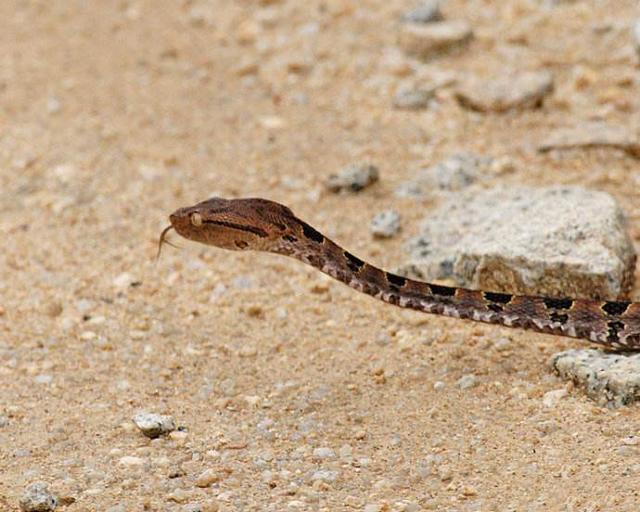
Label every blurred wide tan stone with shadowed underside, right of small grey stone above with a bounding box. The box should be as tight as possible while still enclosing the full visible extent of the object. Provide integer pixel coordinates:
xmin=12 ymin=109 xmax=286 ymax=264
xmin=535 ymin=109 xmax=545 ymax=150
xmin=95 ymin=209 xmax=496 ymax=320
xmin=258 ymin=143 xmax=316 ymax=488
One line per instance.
xmin=456 ymin=71 xmax=553 ymax=112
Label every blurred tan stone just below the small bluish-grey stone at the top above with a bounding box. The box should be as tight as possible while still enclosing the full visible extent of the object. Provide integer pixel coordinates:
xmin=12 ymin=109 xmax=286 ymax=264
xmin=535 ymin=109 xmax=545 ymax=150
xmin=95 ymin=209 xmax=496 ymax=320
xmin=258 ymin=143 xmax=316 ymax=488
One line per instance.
xmin=398 ymin=20 xmax=473 ymax=60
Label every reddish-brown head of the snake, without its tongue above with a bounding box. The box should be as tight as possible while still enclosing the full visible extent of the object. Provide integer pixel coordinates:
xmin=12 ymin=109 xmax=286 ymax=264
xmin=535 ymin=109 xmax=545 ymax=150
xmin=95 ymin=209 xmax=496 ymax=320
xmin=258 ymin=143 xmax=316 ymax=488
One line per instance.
xmin=169 ymin=197 xmax=296 ymax=250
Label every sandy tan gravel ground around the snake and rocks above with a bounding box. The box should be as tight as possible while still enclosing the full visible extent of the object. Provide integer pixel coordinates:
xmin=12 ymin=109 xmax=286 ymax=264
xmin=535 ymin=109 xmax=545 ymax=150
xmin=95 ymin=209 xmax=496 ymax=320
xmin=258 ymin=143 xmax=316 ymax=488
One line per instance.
xmin=0 ymin=0 xmax=640 ymax=512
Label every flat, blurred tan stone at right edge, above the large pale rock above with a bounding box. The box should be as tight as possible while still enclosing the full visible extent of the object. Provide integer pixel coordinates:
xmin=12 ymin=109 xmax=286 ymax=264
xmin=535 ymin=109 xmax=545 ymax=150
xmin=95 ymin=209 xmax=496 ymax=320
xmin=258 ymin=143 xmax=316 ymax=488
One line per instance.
xmin=538 ymin=121 xmax=640 ymax=158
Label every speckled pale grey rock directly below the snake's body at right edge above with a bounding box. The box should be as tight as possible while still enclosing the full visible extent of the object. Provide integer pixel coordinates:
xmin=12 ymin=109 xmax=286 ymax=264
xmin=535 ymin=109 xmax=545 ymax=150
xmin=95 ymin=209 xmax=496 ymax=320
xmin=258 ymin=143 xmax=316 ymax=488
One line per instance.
xmin=550 ymin=349 xmax=640 ymax=408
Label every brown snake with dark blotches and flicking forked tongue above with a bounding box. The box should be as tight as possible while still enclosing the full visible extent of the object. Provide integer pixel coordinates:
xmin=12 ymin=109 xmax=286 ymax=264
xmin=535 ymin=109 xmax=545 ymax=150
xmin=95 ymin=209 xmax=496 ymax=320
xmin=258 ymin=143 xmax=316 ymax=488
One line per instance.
xmin=158 ymin=197 xmax=640 ymax=350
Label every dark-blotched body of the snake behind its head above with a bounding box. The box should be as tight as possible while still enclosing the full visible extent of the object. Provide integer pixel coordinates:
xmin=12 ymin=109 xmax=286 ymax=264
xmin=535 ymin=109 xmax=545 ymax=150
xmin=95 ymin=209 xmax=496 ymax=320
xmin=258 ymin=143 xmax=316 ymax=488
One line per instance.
xmin=274 ymin=230 xmax=640 ymax=350
